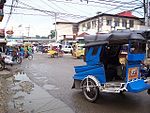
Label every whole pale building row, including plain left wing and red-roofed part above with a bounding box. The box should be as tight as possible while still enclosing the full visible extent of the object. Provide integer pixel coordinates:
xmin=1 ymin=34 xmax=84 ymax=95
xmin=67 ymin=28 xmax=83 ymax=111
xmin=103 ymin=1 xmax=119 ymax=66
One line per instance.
xmin=56 ymin=11 xmax=144 ymax=40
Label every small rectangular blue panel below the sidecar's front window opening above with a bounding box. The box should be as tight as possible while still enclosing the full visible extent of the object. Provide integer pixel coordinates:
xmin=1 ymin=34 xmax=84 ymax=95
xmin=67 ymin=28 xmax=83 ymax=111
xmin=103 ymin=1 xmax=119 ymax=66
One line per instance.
xmin=128 ymin=53 xmax=145 ymax=61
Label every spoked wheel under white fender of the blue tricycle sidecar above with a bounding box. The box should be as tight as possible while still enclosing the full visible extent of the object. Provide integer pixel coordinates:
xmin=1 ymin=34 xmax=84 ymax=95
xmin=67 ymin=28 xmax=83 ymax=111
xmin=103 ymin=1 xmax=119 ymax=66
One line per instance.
xmin=82 ymin=78 xmax=99 ymax=102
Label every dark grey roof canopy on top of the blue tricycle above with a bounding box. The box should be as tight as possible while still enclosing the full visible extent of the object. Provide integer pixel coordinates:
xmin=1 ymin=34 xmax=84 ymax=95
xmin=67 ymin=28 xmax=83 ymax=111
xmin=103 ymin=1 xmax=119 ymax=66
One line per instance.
xmin=84 ymin=32 xmax=145 ymax=47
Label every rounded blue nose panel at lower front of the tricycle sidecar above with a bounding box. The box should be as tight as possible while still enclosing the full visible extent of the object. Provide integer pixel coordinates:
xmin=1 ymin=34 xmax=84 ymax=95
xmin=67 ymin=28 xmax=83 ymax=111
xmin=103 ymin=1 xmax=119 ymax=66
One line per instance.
xmin=127 ymin=80 xmax=150 ymax=93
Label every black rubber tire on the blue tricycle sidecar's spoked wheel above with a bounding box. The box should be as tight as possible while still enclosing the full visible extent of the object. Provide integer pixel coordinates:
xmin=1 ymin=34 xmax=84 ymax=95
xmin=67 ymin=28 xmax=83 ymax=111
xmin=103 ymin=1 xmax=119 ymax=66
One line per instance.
xmin=82 ymin=78 xmax=99 ymax=102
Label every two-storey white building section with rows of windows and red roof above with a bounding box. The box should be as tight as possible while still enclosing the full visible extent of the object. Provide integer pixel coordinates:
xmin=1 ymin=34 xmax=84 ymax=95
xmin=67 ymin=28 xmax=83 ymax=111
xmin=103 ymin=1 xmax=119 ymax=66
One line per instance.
xmin=78 ymin=12 xmax=143 ymax=34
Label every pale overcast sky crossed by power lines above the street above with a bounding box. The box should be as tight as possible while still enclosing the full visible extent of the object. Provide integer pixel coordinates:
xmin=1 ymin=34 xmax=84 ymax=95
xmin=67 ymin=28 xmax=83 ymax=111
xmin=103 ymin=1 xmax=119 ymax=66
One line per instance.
xmin=0 ymin=0 xmax=143 ymax=36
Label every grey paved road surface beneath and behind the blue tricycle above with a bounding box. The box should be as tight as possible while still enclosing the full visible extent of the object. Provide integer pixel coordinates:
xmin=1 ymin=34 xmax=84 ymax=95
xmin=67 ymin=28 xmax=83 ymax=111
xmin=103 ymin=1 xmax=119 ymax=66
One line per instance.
xmin=22 ymin=54 xmax=150 ymax=113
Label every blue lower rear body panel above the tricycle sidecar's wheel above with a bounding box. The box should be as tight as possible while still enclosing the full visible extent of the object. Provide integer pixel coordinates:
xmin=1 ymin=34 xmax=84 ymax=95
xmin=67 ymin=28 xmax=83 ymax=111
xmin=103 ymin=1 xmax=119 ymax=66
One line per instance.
xmin=73 ymin=66 xmax=106 ymax=83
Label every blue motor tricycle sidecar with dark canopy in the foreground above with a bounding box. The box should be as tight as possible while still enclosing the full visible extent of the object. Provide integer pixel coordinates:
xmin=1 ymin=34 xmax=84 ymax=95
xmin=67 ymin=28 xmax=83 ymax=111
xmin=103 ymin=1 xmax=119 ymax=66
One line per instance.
xmin=72 ymin=32 xmax=150 ymax=102
